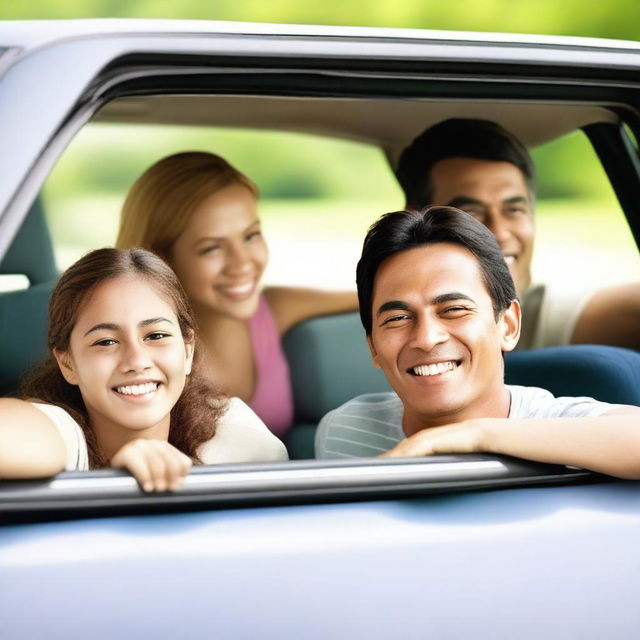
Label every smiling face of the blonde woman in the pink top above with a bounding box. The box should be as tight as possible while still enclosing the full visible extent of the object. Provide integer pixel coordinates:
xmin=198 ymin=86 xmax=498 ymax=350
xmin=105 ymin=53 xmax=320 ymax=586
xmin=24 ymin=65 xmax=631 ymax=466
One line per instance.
xmin=169 ymin=184 xmax=268 ymax=320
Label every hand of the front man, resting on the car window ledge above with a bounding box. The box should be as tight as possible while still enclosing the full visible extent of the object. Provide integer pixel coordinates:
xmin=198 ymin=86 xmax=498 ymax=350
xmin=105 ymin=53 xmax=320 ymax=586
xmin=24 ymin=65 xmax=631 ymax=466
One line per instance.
xmin=381 ymin=420 xmax=487 ymax=458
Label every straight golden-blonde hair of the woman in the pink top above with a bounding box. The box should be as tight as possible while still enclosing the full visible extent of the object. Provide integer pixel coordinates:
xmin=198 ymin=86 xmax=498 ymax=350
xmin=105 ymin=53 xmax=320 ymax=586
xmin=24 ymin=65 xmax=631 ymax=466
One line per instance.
xmin=116 ymin=151 xmax=258 ymax=259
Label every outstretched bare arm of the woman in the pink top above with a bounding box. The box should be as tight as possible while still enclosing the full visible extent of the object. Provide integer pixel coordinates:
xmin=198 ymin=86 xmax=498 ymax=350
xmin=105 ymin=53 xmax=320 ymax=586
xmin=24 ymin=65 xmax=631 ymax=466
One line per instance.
xmin=265 ymin=287 xmax=358 ymax=335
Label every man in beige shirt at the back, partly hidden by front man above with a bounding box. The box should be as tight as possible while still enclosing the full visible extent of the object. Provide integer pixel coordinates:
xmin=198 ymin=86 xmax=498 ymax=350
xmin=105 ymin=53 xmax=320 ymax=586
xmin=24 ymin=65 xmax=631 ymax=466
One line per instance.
xmin=396 ymin=119 xmax=640 ymax=349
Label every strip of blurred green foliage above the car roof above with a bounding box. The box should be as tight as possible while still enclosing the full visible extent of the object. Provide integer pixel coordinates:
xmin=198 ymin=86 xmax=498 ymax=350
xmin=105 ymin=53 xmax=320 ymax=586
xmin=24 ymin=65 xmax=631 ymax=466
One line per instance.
xmin=0 ymin=0 xmax=640 ymax=40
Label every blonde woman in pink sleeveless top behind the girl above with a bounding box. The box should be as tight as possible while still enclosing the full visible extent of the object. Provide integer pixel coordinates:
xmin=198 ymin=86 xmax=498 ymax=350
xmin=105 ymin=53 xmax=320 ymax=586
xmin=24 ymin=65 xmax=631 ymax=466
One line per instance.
xmin=116 ymin=152 xmax=358 ymax=436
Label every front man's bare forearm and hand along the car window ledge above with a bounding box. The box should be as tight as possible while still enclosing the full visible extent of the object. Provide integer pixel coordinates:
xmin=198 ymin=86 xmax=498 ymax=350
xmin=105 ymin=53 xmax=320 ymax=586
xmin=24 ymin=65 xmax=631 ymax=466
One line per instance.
xmin=384 ymin=406 xmax=640 ymax=480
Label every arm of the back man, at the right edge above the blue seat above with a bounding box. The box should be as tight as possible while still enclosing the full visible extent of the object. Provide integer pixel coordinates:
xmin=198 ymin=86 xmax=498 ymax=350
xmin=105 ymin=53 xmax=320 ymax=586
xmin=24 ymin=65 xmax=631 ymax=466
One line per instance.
xmin=571 ymin=283 xmax=640 ymax=350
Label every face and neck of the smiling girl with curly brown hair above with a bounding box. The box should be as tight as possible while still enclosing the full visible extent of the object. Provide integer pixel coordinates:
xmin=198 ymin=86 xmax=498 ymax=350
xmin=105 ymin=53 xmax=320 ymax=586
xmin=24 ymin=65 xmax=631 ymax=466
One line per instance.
xmin=55 ymin=276 xmax=193 ymax=439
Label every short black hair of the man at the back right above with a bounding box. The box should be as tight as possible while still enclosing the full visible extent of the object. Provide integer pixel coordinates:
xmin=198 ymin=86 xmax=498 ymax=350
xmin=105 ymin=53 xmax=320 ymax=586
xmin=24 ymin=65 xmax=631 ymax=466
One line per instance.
xmin=396 ymin=118 xmax=535 ymax=209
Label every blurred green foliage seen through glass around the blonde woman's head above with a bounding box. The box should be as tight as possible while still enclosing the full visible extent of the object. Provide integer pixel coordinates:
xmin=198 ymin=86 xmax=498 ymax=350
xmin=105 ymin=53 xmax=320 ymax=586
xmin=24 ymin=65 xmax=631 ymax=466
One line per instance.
xmin=46 ymin=124 xmax=402 ymax=206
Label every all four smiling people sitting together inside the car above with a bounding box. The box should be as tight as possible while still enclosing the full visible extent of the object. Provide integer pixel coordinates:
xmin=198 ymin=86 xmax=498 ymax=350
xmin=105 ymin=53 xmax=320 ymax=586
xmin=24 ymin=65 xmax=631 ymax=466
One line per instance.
xmin=0 ymin=120 xmax=640 ymax=484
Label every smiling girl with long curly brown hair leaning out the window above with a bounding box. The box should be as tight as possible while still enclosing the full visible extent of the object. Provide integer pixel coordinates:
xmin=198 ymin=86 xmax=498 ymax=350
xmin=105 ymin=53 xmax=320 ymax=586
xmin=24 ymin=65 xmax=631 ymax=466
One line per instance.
xmin=0 ymin=249 xmax=286 ymax=491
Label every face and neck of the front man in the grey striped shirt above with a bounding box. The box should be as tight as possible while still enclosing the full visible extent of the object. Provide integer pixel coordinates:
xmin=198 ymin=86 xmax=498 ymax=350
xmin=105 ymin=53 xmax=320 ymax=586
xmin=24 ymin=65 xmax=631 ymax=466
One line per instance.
xmin=368 ymin=243 xmax=520 ymax=435
